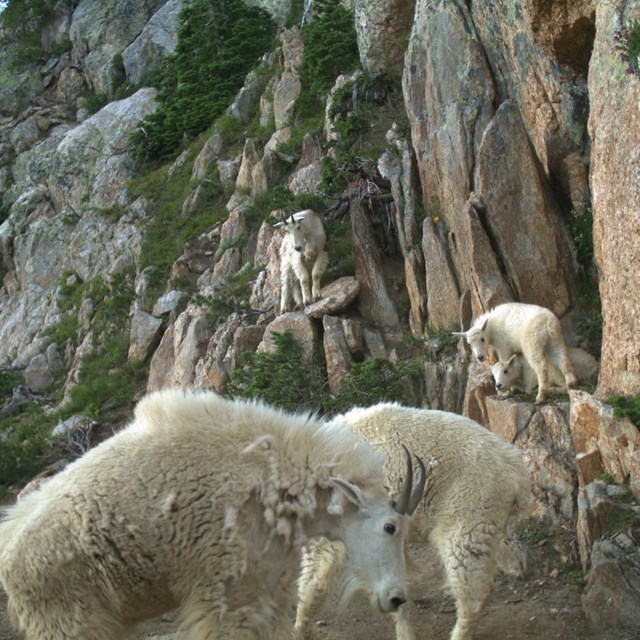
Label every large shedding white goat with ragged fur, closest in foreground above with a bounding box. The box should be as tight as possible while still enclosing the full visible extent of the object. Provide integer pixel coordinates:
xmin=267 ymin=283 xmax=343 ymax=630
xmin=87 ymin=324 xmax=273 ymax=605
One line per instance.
xmin=0 ymin=390 xmax=424 ymax=640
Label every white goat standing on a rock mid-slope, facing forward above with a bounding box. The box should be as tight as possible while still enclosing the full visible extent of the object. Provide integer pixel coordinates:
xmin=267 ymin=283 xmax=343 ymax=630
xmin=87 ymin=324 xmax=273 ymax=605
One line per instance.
xmin=279 ymin=209 xmax=329 ymax=313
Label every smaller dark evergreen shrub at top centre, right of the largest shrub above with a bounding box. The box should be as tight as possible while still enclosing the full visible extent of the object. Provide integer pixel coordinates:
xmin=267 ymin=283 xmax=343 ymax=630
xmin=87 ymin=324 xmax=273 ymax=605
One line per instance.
xmin=301 ymin=0 xmax=360 ymax=93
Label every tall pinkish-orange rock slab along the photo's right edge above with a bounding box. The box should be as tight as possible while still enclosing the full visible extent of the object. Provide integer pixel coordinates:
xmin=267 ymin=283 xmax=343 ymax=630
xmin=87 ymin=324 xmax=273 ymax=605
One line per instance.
xmin=589 ymin=2 xmax=640 ymax=398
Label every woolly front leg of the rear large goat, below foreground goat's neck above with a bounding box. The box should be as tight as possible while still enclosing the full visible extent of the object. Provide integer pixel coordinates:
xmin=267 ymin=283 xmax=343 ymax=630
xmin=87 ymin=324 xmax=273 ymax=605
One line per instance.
xmin=295 ymin=539 xmax=346 ymax=640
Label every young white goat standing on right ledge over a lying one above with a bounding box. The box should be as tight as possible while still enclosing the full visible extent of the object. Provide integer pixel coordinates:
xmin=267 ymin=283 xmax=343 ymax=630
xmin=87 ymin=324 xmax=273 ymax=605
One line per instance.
xmin=453 ymin=302 xmax=577 ymax=403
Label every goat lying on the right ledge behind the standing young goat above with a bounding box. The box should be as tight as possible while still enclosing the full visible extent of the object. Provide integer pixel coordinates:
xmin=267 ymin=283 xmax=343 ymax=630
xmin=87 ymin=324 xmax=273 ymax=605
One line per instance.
xmin=491 ymin=347 xmax=598 ymax=396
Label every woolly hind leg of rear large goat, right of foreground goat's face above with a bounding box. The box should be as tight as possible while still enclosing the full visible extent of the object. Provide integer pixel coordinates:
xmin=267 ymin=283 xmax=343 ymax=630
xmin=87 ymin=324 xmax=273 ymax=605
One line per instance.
xmin=441 ymin=524 xmax=499 ymax=640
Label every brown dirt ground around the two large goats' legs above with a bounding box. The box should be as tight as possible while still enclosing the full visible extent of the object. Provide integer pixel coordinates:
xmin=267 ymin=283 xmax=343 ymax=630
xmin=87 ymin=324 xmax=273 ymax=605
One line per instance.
xmin=0 ymin=540 xmax=640 ymax=640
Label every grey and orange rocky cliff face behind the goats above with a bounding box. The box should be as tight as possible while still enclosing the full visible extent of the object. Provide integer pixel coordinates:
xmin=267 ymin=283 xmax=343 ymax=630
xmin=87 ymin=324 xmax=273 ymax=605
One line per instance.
xmin=0 ymin=0 xmax=640 ymax=628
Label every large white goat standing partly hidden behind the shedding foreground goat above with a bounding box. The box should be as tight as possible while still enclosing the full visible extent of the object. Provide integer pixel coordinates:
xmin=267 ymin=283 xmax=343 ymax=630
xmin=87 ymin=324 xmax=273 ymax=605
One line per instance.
xmin=295 ymin=404 xmax=532 ymax=640
